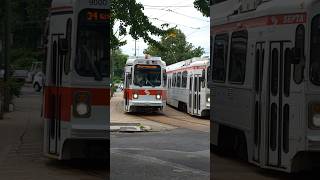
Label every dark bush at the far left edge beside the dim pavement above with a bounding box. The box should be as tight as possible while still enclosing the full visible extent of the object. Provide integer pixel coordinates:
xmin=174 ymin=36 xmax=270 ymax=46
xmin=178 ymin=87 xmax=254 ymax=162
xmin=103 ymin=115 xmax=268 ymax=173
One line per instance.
xmin=0 ymin=78 xmax=23 ymax=112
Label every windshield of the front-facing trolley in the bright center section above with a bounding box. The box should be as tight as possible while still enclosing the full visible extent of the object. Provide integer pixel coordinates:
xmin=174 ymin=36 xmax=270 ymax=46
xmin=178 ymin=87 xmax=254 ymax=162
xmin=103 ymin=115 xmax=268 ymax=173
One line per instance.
xmin=133 ymin=65 xmax=161 ymax=87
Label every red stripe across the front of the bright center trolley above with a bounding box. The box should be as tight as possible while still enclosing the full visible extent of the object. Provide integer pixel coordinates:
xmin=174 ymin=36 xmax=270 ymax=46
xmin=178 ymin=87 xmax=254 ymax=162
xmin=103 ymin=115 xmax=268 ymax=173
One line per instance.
xmin=123 ymin=89 xmax=167 ymax=100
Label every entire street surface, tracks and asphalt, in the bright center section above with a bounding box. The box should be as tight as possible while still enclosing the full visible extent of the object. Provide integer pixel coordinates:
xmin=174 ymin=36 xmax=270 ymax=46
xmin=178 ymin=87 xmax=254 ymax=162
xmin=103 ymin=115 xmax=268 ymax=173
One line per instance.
xmin=110 ymin=93 xmax=210 ymax=180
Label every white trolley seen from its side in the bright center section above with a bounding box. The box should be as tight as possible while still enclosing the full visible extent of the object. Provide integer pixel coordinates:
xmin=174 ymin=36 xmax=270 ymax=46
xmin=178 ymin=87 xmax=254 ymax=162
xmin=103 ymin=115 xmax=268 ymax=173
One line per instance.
xmin=167 ymin=58 xmax=210 ymax=116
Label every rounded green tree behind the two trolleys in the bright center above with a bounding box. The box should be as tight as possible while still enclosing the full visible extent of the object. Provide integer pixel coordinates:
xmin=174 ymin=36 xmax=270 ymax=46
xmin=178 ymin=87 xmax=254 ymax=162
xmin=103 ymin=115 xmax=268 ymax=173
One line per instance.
xmin=145 ymin=28 xmax=205 ymax=65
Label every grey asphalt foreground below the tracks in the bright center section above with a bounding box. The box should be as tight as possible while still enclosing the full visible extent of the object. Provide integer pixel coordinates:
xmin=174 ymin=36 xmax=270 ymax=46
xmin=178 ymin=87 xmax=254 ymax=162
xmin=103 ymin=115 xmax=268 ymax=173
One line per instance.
xmin=110 ymin=129 xmax=210 ymax=180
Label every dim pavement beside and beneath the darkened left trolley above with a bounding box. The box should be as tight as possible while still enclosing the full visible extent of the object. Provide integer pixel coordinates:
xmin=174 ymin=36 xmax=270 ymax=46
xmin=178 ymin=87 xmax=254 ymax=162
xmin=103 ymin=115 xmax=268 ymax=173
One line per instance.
xmin=0 ymin=85 xmax=106 ymax=180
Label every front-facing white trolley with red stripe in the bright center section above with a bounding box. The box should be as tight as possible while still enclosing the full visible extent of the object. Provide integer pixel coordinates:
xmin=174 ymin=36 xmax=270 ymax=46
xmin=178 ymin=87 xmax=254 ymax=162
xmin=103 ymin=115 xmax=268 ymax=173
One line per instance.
xmin=124 ymin=56 xmax=167 ymax=112
